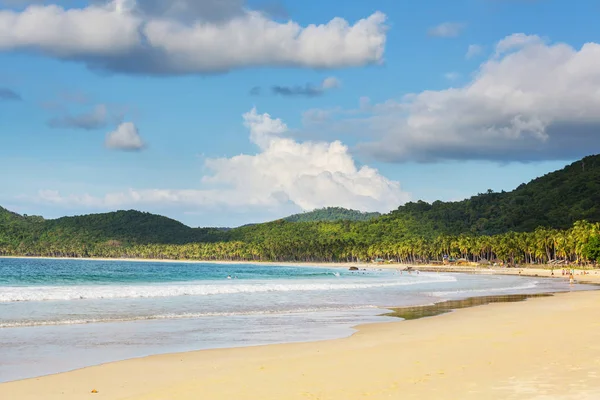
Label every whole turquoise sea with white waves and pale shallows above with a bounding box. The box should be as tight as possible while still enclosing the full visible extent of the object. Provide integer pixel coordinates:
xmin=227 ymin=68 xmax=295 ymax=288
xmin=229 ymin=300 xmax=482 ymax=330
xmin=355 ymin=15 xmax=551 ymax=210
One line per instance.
xmin=0 ymin=258 xmax=589 ymax=382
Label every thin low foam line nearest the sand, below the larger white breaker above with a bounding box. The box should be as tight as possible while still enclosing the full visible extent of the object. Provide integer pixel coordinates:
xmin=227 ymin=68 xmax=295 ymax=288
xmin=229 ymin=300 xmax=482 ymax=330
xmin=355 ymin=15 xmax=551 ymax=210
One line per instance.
xmin=0 ymin=305 xmax=379 ymax=329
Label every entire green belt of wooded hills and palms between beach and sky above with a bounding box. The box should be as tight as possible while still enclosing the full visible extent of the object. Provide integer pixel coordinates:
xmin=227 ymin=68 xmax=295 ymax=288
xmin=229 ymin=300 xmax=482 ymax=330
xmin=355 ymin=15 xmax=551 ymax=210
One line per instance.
xmin=0 ymin=156 xmax=600 ymax=262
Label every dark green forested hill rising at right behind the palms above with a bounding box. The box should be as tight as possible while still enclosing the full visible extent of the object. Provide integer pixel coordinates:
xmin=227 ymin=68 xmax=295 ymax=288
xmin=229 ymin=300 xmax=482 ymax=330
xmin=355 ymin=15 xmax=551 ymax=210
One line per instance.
xmin=384 ymin=155 xmax=600 ymax=234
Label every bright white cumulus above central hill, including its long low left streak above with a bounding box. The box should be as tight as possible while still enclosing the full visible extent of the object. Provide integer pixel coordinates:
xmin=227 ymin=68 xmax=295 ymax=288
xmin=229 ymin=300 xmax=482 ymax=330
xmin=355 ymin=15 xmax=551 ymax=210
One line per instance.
xmin=39 ymin=109 xmax=409 ymax=211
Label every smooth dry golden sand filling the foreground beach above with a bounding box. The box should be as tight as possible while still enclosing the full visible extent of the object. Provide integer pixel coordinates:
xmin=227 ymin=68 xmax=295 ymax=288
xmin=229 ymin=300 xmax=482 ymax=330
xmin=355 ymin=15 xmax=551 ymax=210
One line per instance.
xmin=0 ymin=291 xmax=600 ymax=400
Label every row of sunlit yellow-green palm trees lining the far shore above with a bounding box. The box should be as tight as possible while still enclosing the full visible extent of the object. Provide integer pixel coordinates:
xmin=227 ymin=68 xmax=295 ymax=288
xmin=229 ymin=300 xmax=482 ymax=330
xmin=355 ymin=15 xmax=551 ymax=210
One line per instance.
xmin=0 ymin=221 xmax=600 ymax=264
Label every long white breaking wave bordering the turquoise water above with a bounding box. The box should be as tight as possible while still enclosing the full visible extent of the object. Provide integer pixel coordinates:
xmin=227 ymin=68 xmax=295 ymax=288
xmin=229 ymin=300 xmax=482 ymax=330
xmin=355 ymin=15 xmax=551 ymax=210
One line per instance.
xmin=0 ymin=275 xmax=456 ymax=303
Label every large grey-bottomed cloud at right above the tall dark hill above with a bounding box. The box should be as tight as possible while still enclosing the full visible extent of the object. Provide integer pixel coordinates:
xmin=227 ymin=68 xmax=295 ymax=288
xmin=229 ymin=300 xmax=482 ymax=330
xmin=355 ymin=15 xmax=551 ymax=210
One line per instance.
xmin=308 ymin=34 xmax=600 ymax=162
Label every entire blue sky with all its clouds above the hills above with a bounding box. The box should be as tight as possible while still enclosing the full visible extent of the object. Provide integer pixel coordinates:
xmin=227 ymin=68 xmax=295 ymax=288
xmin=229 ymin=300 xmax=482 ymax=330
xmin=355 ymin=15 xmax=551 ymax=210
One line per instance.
xmin=0 ymin=0 xmax=600 ymax=226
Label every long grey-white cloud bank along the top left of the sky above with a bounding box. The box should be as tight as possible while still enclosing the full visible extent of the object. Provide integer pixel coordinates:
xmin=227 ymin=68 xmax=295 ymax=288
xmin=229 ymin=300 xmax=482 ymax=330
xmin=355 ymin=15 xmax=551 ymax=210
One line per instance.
xmin=0 ymin=0 xmax=386 ymax=74
